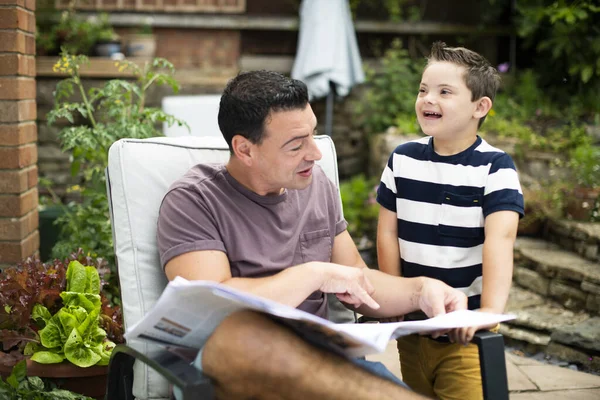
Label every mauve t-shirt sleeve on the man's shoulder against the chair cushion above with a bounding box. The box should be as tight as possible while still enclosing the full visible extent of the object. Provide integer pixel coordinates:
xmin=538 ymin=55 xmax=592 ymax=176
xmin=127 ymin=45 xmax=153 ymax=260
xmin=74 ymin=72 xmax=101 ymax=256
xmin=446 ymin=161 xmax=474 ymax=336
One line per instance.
xmin=157 ymin=188 xmax=225 ymax=268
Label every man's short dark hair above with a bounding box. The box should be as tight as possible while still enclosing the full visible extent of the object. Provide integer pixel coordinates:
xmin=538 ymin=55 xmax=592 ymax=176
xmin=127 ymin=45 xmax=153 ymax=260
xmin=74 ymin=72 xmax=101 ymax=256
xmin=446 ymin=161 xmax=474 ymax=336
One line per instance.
xmin=219 ymin=71 xmax=308 ymax=151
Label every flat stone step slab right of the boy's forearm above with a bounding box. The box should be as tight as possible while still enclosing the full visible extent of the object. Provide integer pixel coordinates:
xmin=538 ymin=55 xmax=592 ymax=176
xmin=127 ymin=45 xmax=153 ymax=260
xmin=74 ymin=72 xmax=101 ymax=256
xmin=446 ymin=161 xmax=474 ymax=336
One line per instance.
xmin=515 ymin=238 xmax=600 ymax=284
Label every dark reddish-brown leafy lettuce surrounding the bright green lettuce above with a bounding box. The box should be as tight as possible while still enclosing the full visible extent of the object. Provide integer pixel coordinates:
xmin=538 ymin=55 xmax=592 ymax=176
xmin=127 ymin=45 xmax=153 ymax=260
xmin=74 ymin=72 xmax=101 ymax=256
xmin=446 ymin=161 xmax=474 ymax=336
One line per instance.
xmin=0 ymin=249 xmax=123 ymax=366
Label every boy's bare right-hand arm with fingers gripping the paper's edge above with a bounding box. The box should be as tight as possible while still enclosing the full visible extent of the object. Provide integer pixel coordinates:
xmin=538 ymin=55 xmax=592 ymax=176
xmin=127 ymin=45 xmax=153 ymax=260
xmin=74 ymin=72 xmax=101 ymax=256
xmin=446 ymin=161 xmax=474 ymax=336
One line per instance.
xmin=450 ymin=211 xmax=519 ymax=344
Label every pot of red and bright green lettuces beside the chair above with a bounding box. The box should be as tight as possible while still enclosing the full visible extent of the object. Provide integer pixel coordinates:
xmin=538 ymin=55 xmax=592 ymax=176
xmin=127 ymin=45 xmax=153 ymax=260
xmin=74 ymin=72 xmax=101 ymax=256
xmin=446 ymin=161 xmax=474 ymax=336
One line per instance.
xmin=0 ymin=250 xmax=123 ymax=397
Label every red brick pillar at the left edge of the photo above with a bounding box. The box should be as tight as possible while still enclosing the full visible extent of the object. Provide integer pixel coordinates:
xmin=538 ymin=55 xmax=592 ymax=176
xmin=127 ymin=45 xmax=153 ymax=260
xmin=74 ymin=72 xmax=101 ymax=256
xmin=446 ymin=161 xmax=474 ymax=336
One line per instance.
xmin=0 ymin=0 xmax=40 ymax=266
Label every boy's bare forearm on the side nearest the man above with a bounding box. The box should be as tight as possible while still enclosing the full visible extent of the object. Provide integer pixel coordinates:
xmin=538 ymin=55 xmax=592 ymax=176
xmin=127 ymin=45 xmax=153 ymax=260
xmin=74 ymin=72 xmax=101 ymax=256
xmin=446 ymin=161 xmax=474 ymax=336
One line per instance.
xmin=377 ymin=207 xmax=400 ymax=276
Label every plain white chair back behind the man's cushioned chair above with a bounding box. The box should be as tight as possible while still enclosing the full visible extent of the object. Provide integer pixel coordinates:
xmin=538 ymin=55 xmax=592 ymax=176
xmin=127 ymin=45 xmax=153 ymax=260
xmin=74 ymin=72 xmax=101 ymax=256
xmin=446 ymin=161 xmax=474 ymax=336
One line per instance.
xmin=161 ymin=94 xmax=222 ymax=137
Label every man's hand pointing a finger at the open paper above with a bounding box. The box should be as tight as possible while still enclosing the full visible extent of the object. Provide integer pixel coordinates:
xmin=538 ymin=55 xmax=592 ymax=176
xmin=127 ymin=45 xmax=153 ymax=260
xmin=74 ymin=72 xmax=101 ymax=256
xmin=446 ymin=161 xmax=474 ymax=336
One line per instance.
xmin=310 ymin=262 xmax=379 ymax=310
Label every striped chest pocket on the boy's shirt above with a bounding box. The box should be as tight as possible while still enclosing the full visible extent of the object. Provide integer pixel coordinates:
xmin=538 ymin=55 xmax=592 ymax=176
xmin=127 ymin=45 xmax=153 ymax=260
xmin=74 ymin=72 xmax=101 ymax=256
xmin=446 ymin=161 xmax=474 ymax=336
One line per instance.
xmin=438 ymin=192 xmax=483 ymax=238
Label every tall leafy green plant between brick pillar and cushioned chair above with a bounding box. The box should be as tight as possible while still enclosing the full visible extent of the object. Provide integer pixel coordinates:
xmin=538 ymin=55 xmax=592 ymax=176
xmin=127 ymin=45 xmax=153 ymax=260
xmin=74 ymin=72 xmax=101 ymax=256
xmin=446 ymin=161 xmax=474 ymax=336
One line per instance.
xmin=48 ymin=53 xmax=182 ymax=268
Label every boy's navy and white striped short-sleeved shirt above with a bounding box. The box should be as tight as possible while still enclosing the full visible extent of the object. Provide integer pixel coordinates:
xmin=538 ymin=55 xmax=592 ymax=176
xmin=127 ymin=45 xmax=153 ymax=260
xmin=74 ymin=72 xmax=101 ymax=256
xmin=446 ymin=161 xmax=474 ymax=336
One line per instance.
xmin=377 ymin=136 xmax=524 ymax=309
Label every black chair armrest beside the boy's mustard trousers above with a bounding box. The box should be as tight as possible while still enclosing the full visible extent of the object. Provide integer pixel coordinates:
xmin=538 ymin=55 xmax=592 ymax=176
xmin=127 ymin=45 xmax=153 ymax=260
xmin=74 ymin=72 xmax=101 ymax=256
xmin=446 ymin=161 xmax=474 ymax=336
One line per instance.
xmin=473 ymin=331 xmax=508 ymax=400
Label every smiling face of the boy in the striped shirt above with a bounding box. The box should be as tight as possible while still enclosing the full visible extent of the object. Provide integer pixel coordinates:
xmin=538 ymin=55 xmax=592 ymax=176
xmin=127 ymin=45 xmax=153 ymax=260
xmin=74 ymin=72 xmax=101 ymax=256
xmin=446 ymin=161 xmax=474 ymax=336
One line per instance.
xmin=415 ymin=61 xmax=481 ymax=140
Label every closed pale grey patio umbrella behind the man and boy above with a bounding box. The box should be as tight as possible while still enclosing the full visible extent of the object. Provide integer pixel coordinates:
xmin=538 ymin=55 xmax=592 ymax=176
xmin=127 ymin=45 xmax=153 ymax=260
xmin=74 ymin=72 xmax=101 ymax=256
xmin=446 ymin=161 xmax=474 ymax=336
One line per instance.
xmin=292 ymin=0 xmax=365 ymax=136
